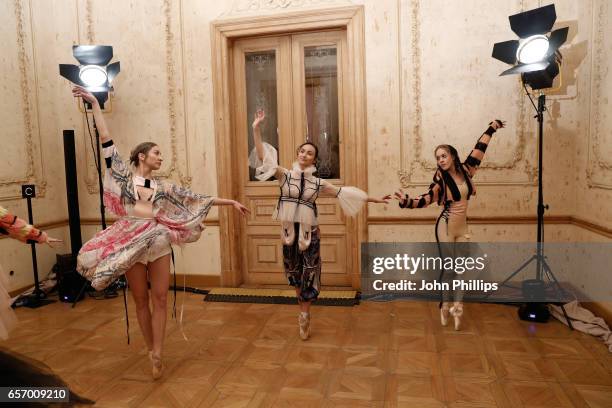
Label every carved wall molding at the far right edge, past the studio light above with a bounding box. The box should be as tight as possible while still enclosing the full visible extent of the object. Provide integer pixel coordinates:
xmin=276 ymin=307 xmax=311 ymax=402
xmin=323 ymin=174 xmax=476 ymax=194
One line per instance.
xmin=586 ymin=0 xmax=612 ymax=190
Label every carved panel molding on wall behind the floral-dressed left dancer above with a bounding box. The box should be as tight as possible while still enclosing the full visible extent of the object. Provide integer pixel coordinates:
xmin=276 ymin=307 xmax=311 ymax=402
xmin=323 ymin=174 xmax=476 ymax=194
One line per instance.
xmin=83 ymin=0 xmax=192 ymax=194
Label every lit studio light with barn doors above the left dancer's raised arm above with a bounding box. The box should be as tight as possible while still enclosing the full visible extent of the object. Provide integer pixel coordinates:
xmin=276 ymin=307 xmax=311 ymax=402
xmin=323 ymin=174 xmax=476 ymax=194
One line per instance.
xmin=59 ymin=45 xmax=121 ymax=108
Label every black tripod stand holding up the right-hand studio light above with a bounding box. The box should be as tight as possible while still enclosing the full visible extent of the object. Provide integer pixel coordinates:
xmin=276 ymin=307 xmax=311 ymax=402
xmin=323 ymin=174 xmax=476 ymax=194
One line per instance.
xmin=492 ymin=93 xmax=574 ymax=330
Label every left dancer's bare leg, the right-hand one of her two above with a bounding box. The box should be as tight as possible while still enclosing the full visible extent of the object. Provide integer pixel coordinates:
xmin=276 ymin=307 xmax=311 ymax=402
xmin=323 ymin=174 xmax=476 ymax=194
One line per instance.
xmin=148 ymin=254 xmax=170 ymax=357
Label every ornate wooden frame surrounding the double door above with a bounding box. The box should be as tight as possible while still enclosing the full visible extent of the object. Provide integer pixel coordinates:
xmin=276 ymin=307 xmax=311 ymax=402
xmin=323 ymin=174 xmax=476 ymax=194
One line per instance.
xmin=211 ymin=6 xmax=367 ymax=288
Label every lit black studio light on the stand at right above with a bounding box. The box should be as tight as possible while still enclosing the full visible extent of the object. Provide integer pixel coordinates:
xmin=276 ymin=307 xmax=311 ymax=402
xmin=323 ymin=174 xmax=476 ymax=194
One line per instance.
xmin=492 ymin=4 xmax=569 ymax=90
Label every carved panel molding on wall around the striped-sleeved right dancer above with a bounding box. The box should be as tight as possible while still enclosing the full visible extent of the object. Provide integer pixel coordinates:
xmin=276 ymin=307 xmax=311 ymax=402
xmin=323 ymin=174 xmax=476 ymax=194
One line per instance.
xmin=397 ymin=0 xmax=537 ymax=188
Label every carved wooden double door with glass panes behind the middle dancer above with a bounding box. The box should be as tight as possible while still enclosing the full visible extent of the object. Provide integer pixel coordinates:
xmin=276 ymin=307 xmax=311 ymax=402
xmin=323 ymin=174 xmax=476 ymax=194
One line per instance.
xmin=231 ymin=30 xmax=365 ymax=287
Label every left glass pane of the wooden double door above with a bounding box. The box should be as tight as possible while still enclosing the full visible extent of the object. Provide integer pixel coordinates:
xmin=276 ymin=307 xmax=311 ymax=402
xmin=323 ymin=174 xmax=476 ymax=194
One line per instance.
xmin=245 ymin=50 xmax=279 ymax=181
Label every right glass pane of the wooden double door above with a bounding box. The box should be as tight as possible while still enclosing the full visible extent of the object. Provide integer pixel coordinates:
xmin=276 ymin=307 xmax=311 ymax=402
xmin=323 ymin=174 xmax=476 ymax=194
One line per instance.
xmin=304 ymin=45 xmax=340 ymax=179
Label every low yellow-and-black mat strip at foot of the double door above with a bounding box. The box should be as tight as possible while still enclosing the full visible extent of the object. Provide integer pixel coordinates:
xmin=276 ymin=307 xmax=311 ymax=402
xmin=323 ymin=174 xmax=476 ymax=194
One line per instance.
xmin=204 ymin=288 xmax=359 ymax=306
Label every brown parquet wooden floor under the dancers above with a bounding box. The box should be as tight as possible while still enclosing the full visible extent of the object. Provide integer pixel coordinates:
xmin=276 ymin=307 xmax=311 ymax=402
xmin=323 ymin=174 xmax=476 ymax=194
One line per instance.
xmin=0 ymin=294 xmax=612 ymax=408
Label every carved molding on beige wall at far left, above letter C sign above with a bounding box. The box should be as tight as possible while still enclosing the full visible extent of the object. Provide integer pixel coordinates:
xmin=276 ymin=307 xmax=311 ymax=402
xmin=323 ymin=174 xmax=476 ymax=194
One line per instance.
xmin=0 ymin=0 xmax=47 ymax=200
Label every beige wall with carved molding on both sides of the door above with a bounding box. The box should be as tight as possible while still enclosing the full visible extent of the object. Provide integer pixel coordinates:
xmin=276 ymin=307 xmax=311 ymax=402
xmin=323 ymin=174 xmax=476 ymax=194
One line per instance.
xmin=0 ymin=0 xmax=612 ymax=296
